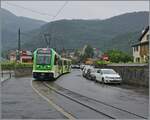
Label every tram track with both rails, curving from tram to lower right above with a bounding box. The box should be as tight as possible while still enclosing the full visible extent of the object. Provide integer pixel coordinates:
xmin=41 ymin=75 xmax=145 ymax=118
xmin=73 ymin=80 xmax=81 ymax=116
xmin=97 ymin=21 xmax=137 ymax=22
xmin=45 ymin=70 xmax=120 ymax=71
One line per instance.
xmin=43 ymin=82 xmax=147 ymax=119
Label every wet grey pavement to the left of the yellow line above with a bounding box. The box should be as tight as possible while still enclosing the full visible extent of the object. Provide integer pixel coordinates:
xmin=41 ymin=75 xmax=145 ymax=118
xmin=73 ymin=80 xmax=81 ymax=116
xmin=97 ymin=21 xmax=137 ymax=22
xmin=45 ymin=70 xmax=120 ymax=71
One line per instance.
xmin=1 ymin=77 xmax=66 ymax=119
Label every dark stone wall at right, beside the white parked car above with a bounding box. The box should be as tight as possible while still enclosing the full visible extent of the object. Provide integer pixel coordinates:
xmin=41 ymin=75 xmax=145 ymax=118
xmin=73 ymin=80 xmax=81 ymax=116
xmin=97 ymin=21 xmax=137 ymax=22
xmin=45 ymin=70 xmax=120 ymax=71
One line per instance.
xmin=95 ymin=64 xmax=149 ymax=87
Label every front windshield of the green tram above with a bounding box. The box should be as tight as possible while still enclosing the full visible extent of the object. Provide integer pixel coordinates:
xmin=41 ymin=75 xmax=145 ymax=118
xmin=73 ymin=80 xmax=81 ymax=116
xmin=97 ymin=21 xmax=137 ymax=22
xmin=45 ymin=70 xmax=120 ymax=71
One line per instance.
xmin=36 ymin=54 xmax=51 ymax=65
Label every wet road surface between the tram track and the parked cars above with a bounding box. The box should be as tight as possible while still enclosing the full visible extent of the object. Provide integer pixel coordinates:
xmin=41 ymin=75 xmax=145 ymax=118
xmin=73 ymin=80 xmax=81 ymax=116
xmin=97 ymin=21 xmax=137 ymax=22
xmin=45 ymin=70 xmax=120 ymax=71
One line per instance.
xmin=55 ymin=69 xmax=149 ymax=118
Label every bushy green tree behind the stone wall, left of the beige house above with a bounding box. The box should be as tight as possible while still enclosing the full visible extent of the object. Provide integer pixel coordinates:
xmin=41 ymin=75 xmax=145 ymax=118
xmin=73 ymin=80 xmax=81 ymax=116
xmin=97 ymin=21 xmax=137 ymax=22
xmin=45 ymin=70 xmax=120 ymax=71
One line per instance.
xmin=106 ymin=50 xmax=133 ymax=63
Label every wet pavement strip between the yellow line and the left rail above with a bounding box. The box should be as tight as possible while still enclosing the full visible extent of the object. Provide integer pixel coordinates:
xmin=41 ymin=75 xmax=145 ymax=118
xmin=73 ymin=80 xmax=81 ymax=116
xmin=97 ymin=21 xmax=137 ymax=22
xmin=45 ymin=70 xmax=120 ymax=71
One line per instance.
xmin=33 ymin=81 xmax=110 ymax=119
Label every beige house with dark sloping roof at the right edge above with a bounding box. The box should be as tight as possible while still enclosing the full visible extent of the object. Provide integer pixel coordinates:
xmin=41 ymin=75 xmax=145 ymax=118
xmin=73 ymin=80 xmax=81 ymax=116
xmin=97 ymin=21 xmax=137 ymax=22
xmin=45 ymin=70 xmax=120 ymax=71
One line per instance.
xmin=132 ymin=26 xmax=149 ymax=63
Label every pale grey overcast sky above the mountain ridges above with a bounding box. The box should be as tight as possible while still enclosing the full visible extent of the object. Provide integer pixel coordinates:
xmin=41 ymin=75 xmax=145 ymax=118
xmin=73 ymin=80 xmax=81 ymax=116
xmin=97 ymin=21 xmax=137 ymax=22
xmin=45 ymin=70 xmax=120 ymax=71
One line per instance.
xmin=1 ymin=1 xmax=149 ymax=22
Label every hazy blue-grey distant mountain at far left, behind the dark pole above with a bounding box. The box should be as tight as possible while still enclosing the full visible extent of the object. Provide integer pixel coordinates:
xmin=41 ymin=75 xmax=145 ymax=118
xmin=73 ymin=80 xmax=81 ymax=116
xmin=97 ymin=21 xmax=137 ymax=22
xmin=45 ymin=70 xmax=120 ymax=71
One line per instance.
xmin=1 ymin=8 xmax=46 ymax=50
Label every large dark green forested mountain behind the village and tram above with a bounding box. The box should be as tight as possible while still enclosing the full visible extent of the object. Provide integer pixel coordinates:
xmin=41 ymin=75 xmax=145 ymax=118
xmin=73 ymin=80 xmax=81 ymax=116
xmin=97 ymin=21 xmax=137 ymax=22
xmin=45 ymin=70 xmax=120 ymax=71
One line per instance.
xmin=1 ymin=9 xmax=149 ymax=53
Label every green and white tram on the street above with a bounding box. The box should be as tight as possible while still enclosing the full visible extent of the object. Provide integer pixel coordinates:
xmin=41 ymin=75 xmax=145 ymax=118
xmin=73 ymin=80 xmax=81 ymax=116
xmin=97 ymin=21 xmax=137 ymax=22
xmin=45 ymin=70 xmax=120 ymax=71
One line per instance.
xmin=32 ymin=48 xmax=71 ymax=79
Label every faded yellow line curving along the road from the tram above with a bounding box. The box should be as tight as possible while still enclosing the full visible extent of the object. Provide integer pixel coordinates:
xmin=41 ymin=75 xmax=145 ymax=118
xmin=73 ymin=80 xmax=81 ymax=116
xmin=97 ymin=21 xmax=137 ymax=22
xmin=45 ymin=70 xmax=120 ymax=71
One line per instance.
xmin=31 ymin=80 xmax=76 ymax=120
